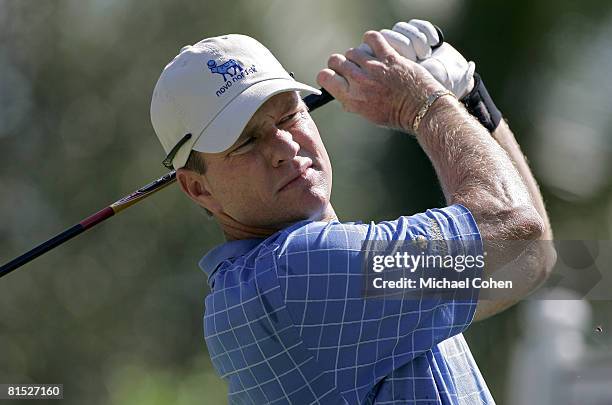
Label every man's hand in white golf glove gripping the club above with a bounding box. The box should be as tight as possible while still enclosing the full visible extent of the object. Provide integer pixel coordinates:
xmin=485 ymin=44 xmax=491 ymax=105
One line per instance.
xmin=358 ymin=19 xmax=476 ymax=99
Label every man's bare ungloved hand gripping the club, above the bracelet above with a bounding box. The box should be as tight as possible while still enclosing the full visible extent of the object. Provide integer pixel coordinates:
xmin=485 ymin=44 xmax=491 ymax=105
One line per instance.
xmin=317 ymin=31 xmax=444 ymax=131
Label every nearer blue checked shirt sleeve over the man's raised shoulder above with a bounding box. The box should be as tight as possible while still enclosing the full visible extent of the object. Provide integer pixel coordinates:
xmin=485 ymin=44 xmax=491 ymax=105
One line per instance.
xmin=275 ymin=205 xmax=482 ymax=400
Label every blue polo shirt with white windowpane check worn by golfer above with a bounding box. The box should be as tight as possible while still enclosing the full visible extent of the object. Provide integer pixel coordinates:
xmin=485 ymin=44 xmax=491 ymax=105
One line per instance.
xmin=200 ymin=205 xmax=494 ymax=405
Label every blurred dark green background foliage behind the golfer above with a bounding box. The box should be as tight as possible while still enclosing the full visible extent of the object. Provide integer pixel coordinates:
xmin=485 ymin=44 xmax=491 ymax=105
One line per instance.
xmin=0 ymin=0 xmax=612 ymax=404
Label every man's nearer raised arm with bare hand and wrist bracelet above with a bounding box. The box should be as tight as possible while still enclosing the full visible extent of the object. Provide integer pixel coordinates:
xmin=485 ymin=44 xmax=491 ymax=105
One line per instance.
xmin=318 ymin=31 xmax=546 ymax=318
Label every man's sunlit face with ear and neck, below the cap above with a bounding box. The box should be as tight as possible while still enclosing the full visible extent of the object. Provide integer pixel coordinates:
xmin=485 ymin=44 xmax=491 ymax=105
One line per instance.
xmin=177 ymin=91 xmax=337 ymax=240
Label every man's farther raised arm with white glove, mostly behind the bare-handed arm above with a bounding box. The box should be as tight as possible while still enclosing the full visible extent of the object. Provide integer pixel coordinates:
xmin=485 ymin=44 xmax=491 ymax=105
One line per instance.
xmin=381 ymin=19 xmax=556 ymax=319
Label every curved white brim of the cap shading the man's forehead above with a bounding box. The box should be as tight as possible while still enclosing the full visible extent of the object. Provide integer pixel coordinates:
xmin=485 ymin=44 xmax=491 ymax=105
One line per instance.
xmin=192 ymin=78 xmax=321 ymax=153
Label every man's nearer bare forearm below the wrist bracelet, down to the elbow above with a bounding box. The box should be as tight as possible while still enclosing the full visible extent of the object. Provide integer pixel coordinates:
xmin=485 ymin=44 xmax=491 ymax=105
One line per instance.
xmin=417 ymin=97 xmax=537 ymax=240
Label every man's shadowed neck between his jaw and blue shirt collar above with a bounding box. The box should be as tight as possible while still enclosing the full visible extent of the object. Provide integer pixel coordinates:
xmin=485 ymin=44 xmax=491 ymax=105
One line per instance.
xmin=215 ymin=204 xmax=338 ymax=241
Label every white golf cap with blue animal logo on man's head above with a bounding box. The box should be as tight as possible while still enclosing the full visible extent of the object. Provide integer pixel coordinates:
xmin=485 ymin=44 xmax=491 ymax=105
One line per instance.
xmin=151 ymin=34 xmax=320 ymax=169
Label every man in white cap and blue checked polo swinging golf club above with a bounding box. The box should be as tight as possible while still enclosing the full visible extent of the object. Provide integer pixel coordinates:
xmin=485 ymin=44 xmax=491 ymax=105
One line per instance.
xmin=151 ymin=20 xmax=554 ymax=404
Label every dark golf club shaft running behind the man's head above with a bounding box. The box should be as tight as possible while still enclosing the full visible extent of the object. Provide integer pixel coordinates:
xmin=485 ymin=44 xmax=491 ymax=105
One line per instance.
xmin=0 ymin=89 xmax=334 ymax=277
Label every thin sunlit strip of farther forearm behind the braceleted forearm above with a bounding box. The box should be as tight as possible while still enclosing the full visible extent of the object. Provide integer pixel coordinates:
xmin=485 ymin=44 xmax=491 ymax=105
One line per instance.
xmin=492 ymin=120 xmax=553 ymax=240
